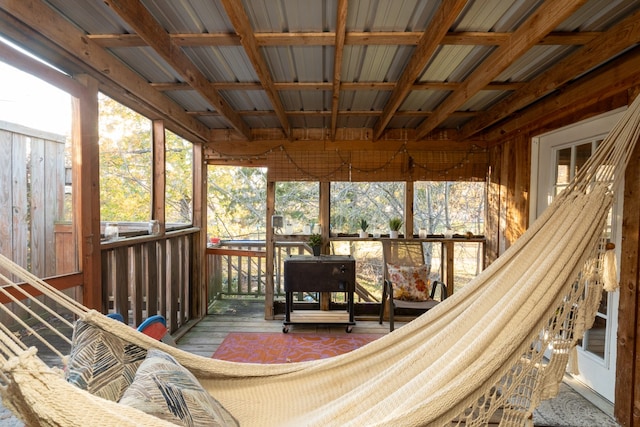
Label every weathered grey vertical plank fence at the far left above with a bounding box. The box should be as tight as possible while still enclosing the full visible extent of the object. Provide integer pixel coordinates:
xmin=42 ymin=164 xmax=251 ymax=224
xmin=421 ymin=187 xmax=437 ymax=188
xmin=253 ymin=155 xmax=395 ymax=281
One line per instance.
xmin=0 ymin=123 xmax=65 ymax=277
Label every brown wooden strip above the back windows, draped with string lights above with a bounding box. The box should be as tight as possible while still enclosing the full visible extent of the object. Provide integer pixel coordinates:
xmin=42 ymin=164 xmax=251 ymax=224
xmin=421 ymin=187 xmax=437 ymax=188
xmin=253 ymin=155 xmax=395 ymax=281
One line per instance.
xmin=265 ymin=149 xmax=488 ymax=182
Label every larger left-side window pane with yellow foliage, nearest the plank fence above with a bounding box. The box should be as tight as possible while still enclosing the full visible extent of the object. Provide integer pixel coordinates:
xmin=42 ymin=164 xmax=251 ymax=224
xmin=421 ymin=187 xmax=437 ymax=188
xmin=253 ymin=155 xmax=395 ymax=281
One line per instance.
xmin=99 ymin=95 xmax=152 ymax=236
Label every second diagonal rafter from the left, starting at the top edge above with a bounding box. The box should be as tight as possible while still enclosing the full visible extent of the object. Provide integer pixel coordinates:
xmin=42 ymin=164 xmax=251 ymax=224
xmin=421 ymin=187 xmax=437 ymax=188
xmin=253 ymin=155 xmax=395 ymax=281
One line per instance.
xmin=105 ymin=0 xmax=251 ymax=138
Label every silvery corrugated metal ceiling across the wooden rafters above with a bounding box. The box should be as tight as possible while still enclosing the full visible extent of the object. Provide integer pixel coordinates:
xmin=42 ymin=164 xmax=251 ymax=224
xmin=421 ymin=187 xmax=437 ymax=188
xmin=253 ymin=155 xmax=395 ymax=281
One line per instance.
xmin=3 ymin=0 xmax=640 ymax=144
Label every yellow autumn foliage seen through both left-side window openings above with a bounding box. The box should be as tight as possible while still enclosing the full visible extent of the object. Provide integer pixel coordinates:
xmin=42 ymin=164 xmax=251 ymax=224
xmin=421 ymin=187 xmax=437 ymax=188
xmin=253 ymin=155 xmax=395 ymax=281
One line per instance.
xmin=99 ymin=95 xmax=193 ymax=224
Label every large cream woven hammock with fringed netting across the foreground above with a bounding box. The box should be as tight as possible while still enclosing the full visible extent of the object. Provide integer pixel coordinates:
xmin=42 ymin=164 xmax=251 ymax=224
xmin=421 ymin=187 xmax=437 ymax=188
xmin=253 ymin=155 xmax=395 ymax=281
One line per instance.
xmin=0 ymin=95 xmax=640 ymax=427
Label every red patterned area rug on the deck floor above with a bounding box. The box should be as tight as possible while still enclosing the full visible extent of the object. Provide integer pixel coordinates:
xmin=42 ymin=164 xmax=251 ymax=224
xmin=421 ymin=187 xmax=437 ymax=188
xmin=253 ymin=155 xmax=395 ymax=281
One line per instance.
xmin=212 ymin=332 xmax=382 ymax=363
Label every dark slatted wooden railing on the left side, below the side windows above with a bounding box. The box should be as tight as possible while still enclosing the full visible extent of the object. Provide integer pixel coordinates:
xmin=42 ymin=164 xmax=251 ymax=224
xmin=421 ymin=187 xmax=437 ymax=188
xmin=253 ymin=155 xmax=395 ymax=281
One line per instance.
xmin=101 ymin=228 xmax=200 ymax=331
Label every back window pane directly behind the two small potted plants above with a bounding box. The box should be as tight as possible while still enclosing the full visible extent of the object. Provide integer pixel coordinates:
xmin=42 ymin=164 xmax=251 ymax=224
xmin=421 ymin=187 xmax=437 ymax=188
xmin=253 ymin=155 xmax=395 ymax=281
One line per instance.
xmin=331 ymin=182 xmax=405 ymax=234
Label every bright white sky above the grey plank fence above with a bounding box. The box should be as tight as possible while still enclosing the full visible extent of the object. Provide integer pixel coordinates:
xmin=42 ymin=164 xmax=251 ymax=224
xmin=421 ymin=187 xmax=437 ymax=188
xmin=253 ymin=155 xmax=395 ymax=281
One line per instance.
xmin=0 ymin=62 xmax=71 ymax=135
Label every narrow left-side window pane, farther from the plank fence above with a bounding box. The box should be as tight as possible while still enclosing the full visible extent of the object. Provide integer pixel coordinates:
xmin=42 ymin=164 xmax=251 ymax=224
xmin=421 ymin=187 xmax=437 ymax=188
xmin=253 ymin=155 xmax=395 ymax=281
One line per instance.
xmin=165 ymin=131 xmax=193 ymax=228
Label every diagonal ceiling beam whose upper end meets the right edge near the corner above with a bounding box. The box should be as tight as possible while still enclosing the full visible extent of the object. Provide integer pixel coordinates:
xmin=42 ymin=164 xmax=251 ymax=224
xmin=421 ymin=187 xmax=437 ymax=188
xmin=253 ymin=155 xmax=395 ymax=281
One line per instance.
xmin=460 ymin=12 xmax=640 ymax=138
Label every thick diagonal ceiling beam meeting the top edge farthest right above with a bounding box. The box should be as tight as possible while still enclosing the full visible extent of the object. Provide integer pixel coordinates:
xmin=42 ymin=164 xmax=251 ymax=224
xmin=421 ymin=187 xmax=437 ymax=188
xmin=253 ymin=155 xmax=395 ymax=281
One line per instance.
xmin=417 ymin=0 xmax=586 ymax=139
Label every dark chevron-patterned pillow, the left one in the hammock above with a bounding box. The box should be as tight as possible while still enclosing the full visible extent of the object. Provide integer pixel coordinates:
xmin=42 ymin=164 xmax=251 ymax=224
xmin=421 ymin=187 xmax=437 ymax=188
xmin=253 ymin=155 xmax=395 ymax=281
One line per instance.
xmin=66 ymin=320 xmax=147 ymax=402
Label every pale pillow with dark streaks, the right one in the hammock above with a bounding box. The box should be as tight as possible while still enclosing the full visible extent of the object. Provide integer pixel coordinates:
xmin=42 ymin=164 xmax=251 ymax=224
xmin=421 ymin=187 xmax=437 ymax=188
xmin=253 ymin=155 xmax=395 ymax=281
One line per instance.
xmin=120 ymin=349 xmax=239 ymax=427
